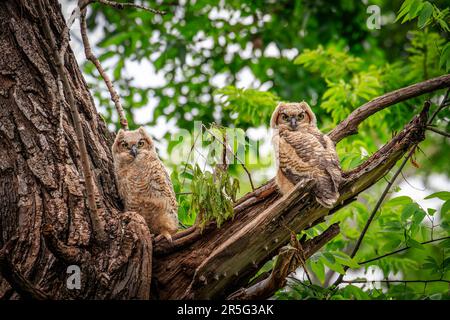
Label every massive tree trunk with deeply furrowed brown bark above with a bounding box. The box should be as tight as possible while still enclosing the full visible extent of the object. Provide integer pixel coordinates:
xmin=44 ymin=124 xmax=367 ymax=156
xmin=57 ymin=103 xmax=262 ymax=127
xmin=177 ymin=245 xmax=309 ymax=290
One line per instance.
xmin=0 ymin=0 xmax=152 ymax=299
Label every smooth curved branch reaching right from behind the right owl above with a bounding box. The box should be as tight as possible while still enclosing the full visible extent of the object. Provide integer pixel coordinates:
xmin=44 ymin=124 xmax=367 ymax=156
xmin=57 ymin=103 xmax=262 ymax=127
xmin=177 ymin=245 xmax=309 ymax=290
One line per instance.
xmin=328 ymin=74 xmax=450 ymax=143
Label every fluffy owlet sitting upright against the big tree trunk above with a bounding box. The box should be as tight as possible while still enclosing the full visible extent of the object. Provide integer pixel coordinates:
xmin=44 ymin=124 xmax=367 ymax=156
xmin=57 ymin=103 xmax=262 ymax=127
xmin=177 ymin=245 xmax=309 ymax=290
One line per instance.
xmin=112 ymin=127 xmax=178 ymax=242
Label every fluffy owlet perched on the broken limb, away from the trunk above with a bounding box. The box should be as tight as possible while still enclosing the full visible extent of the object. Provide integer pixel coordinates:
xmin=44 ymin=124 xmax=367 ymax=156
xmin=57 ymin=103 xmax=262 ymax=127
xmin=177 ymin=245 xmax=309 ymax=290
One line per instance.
xmin=270 ymin=102 xmax=342 ymax=208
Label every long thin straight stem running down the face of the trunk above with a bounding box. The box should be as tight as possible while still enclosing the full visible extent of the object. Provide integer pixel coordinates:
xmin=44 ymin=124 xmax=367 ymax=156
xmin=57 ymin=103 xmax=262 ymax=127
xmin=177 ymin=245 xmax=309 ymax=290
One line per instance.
xmin=37 ymin=0 xmax=107 ymax=242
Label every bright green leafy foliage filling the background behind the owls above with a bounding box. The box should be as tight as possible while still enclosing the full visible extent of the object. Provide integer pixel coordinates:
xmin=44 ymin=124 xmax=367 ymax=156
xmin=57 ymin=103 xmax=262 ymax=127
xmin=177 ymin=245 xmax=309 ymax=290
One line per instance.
xmin=84 ymin=0 xmax=450 ymax=299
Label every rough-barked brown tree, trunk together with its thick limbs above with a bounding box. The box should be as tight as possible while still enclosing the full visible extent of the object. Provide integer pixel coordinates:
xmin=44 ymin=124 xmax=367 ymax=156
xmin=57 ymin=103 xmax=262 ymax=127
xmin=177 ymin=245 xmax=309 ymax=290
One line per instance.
xmin=0 ymin=0 xmax=450 ymax=299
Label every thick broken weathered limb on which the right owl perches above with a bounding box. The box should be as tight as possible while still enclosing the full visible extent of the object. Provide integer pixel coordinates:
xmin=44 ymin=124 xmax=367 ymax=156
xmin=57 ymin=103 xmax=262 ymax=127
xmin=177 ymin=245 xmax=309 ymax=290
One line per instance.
xmin=154 ymin=104 xmax=426 ymax=299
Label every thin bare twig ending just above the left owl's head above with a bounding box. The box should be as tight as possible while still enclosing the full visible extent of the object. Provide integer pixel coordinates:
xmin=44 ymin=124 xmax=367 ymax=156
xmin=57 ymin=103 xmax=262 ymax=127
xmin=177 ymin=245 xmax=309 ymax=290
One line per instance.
xmin=80 ymin=9 xmax=128 ymax=130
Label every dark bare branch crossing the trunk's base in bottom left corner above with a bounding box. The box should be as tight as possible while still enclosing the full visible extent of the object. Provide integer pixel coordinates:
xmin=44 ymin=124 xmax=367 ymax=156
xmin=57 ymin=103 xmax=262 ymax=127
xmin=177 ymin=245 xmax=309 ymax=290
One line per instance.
xmin=0 ymin=238 xmax=51 ymax=300
